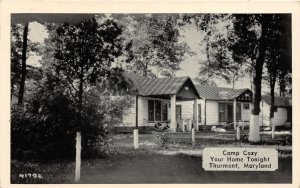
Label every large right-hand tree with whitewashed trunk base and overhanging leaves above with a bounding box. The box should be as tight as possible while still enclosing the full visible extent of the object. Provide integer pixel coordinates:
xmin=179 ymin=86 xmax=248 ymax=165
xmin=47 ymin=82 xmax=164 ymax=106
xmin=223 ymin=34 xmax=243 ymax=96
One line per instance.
xmin=187 ymin=14 xmax=291 ymax=141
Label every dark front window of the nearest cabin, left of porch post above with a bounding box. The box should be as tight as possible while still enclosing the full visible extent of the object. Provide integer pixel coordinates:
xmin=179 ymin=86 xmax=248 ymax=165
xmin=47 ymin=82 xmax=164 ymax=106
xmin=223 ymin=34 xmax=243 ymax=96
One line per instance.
xmin=148 ymin=100 xmax=168 ymax=121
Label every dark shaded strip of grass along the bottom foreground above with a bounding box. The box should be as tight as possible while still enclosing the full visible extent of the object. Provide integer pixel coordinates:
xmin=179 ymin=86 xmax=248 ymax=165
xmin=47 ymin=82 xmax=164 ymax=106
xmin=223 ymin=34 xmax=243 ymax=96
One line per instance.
xmin=11 ymin=151 xmax=292 ymax=184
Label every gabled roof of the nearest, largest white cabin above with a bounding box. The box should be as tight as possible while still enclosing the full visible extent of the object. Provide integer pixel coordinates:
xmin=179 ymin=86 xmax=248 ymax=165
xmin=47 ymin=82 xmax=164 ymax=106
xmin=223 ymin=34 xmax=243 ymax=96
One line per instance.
xmin=123 ymin=72 xmax=200 ymax=98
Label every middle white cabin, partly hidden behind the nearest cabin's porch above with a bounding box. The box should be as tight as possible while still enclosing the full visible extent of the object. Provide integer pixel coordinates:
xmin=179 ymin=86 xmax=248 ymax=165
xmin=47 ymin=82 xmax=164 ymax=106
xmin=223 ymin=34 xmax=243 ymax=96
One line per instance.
xmin=177 ymin=85 xmax=252 ymax=130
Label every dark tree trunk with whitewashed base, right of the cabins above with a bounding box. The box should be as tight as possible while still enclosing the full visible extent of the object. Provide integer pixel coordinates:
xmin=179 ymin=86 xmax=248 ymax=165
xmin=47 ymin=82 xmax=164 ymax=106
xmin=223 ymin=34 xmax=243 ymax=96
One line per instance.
xmin=249 ymin=23 xmax=266 ymax=142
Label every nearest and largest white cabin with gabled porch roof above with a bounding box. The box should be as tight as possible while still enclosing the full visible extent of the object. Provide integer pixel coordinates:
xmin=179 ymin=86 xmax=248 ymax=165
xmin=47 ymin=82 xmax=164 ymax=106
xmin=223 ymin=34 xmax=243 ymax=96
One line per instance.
xmin=119 ymin=72 xmax=201 ymax=132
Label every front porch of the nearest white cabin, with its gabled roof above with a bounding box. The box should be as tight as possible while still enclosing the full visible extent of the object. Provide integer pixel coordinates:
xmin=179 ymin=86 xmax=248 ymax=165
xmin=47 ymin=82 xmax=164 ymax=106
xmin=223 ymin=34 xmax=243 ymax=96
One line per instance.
xmin=135 ymin=77 xmax=200 ymax=132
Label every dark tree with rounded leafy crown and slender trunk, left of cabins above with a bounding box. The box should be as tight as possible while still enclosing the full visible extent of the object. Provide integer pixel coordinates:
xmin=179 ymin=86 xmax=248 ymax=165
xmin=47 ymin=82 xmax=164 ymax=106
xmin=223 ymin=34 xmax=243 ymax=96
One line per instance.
xmin=45 ymin=19 xmax=122 ymax=131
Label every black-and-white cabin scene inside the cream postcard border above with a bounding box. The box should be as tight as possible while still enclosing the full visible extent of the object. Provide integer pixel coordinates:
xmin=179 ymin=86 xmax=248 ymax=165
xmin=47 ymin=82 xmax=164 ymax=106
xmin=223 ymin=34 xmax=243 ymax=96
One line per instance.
xmin=0 ymin=0 xmax=299 ymax=186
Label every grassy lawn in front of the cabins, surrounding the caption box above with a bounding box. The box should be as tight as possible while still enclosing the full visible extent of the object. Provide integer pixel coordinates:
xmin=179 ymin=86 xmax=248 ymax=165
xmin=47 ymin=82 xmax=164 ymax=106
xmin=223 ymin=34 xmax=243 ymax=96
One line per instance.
xmin=12 ymin=132 xmax=292 ymax=184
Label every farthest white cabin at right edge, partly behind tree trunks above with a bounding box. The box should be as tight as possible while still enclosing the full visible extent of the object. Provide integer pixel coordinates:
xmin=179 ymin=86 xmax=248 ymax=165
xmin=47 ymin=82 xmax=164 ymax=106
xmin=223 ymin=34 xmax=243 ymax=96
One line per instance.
xmin=260 ymin=95 xmax=292 ymax=127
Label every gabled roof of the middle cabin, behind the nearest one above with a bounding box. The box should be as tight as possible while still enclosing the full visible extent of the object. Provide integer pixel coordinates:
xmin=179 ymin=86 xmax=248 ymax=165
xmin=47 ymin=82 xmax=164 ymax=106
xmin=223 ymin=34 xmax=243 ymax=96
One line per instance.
xmin=196 ymin=85 xmax=250 ymax=100
